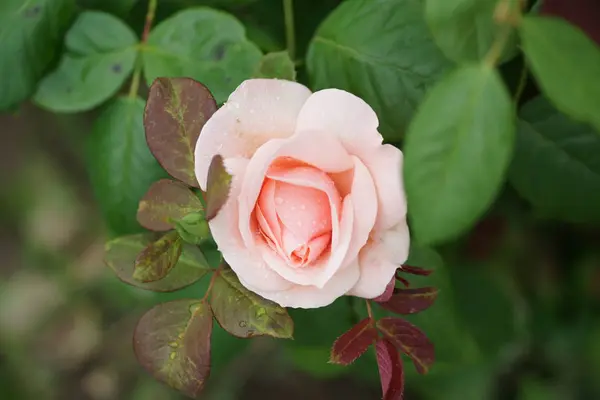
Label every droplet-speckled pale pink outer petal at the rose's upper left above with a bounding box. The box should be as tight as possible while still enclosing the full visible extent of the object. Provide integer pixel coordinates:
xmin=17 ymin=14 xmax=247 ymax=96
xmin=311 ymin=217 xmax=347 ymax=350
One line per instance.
xmin=195 ymin=79 xmax=311 ymax=190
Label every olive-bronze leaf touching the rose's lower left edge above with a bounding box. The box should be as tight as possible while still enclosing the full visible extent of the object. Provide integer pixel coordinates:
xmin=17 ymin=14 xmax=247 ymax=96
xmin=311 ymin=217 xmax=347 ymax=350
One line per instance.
xmin=210 ymin=268 xmax=294 ymax=339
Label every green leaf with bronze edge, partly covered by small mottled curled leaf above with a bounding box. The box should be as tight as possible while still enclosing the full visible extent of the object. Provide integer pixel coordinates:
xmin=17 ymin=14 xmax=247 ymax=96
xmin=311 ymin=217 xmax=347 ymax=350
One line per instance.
xmin=104 ymin=234 xmax=210 ymax=292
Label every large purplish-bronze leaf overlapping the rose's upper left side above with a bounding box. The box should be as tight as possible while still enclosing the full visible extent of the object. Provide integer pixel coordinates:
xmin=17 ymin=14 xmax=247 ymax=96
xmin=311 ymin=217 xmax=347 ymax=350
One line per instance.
xmin=144 ymin=78 xmax=217 ymax=187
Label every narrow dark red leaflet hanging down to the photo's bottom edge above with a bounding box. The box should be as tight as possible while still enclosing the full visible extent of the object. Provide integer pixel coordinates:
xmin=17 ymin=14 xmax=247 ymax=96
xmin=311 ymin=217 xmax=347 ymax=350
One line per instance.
xmin=375 ymin=338 xmax=404 ymax=400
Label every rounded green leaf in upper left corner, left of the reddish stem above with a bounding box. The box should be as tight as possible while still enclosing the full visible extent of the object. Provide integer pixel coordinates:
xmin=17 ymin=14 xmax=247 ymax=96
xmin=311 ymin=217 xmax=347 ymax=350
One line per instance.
xmin=34 ymin=11 xmax=137 ymax=112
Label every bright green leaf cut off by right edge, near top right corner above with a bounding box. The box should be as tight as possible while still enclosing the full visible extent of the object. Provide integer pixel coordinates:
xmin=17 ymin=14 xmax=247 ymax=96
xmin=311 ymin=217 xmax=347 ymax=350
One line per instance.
xmin=521 ymin=16 xmax=600 ymax=133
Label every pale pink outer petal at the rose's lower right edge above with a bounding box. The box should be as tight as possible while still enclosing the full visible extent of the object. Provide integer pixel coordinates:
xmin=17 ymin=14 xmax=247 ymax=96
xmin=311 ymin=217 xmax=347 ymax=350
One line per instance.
xmin=348 ymin=222 xmax=410 ymax=299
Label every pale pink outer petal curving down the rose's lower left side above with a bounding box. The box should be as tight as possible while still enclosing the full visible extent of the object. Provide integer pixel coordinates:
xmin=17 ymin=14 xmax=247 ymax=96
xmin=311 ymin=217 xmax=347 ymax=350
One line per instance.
xmin=209 ymin=158 xmax=292 ymax=290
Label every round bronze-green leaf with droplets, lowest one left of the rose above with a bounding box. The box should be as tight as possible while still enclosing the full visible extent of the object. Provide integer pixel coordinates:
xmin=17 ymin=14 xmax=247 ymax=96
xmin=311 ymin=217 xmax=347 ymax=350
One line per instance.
xmin=133 ymin=300 xmax=213 ymax=398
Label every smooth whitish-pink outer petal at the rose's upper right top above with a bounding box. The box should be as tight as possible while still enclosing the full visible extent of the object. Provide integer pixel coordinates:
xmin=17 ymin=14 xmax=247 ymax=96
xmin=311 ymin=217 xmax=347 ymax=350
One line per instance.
xmin=296 ymin=89 xmax=383 ymax=159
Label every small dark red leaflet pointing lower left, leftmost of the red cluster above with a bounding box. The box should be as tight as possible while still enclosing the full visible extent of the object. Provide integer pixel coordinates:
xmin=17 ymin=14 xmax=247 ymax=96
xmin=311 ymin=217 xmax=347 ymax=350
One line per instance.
xmin=329 ymin=318 xmax=377 ymax=365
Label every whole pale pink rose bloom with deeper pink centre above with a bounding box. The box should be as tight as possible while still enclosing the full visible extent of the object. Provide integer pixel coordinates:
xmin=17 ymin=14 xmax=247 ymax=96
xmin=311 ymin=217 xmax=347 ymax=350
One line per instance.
xmin=195 ymin=79 xmax=409 ymax=308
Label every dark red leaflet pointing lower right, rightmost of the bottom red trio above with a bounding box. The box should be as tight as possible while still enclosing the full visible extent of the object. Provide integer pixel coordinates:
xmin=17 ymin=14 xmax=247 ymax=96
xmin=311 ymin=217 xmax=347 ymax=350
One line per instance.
xmin=377 ymin=317 xmax=435 ymax=374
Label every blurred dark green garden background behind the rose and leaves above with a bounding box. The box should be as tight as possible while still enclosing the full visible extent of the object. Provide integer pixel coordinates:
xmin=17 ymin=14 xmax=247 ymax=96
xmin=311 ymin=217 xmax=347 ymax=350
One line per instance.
xmin=0 ymin=0 xmax=600 ymax=400
